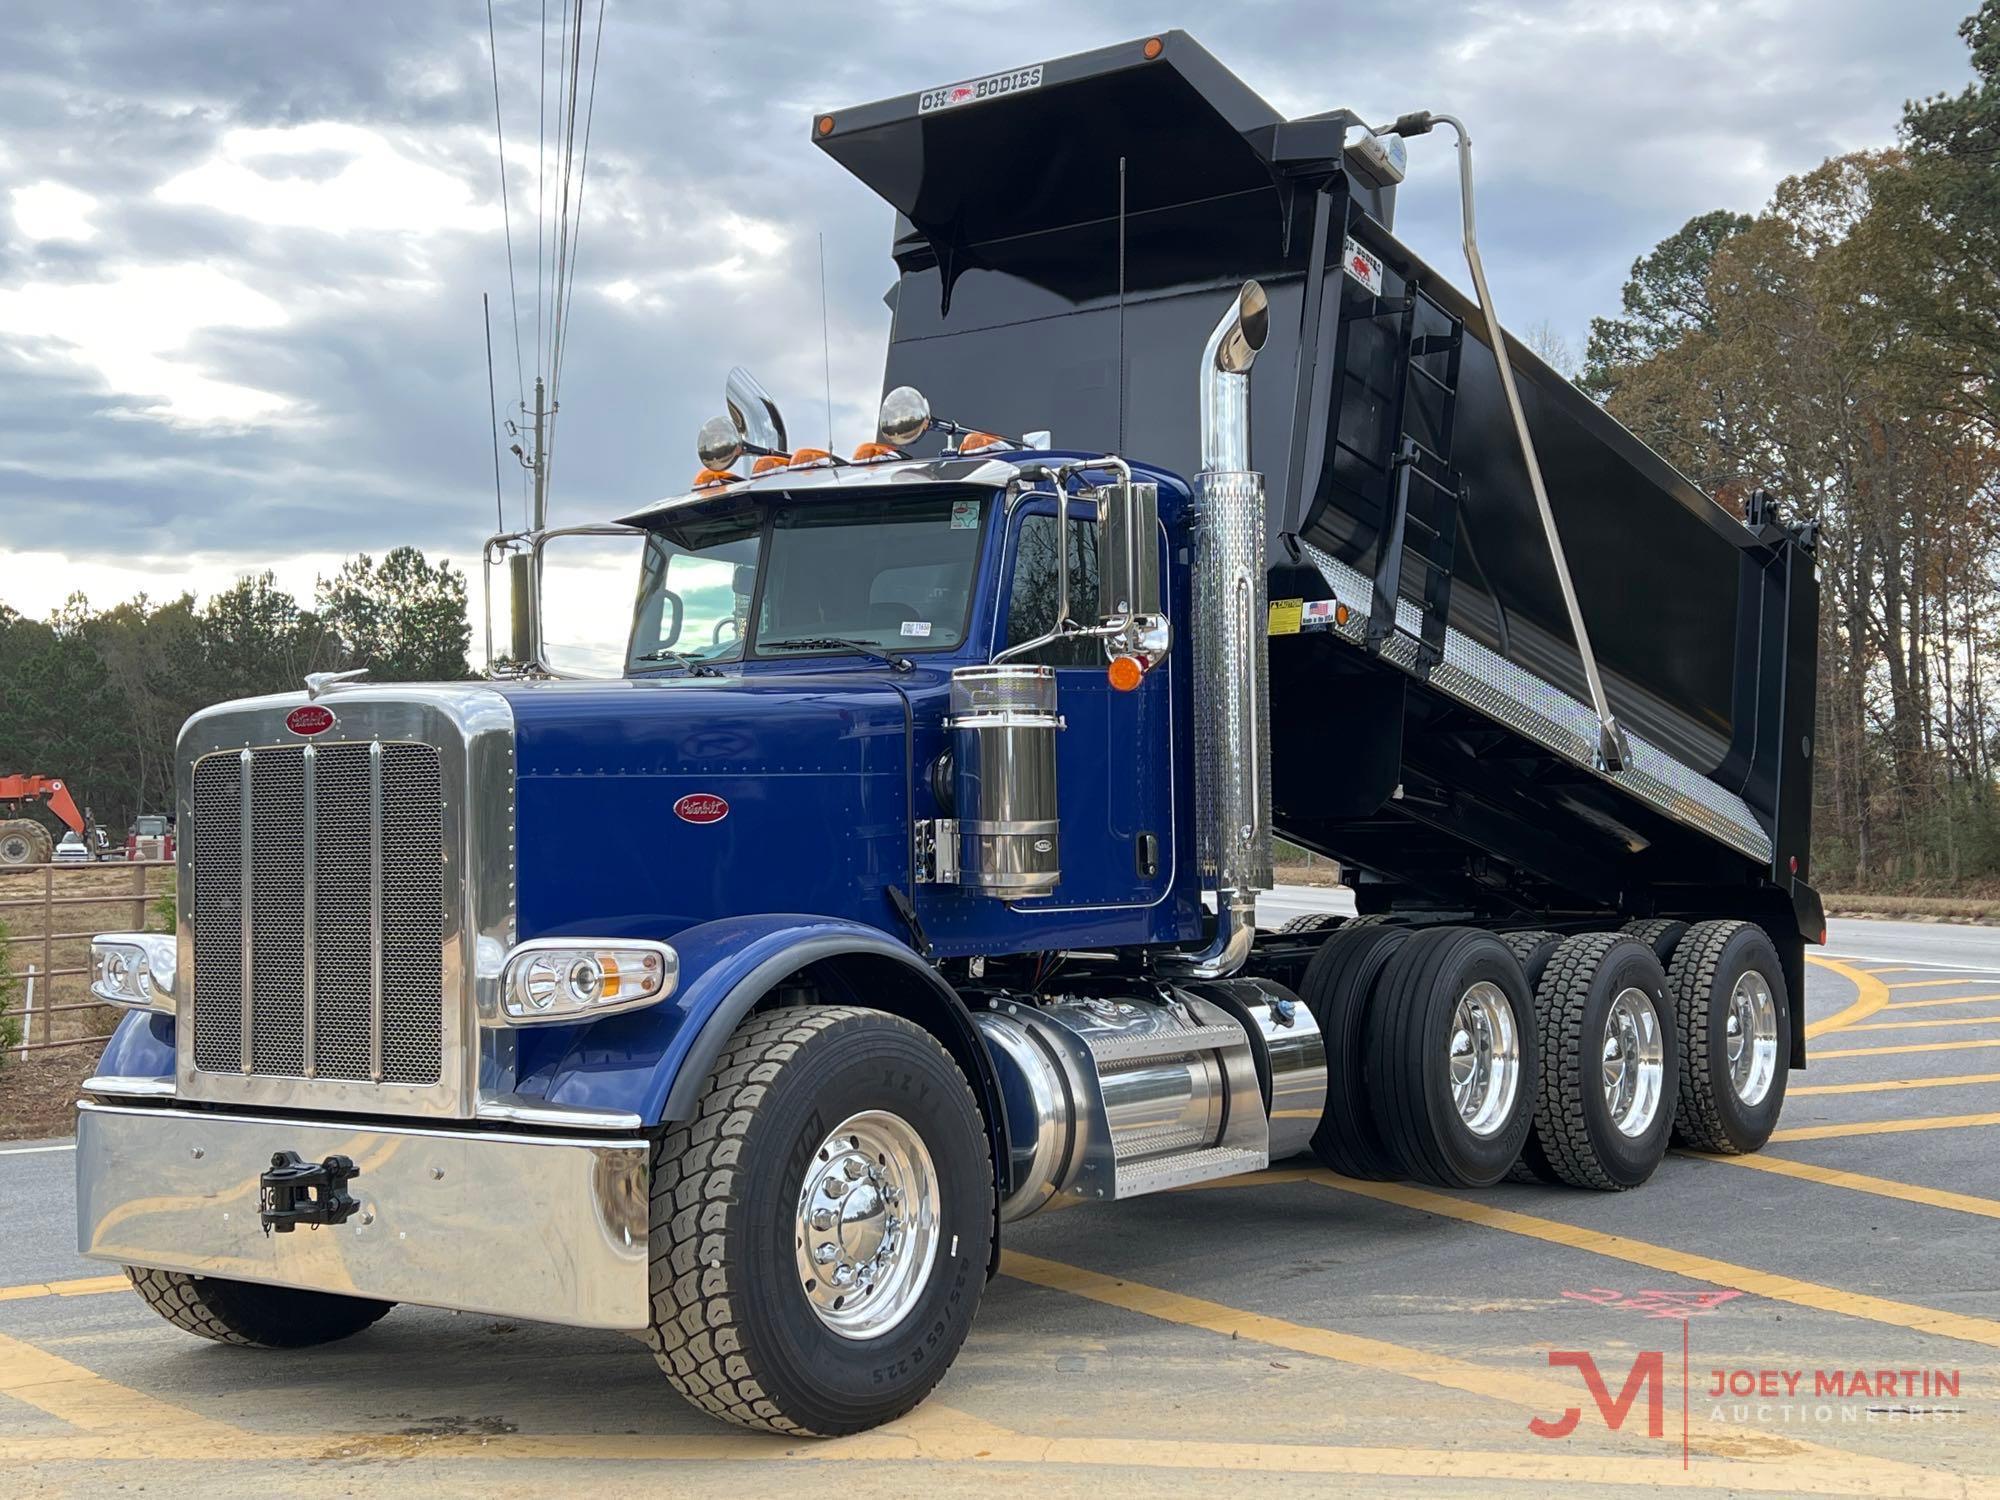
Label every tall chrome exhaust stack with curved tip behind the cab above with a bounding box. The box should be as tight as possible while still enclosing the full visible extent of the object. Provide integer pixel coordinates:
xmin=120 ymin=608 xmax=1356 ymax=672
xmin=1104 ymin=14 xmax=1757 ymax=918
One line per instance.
xmin=1162 ymin=282 xmax=1272 ymax=980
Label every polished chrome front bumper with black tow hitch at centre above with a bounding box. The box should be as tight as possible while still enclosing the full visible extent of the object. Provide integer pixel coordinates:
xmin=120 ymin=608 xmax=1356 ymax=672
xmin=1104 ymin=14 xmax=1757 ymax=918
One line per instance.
xmin=76 ymin=1100 xmax=648 ymax=1330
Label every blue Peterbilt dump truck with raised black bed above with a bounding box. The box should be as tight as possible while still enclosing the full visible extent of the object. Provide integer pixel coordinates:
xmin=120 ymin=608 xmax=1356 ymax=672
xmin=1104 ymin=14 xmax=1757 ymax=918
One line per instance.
xmin=76 ymin=32 xmax=1824 ymax=1434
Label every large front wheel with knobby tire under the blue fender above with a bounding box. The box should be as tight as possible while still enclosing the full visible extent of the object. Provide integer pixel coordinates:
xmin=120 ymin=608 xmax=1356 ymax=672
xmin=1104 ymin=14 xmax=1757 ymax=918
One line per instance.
xmin=650 ymin=1006 xmax=994 ymax=1438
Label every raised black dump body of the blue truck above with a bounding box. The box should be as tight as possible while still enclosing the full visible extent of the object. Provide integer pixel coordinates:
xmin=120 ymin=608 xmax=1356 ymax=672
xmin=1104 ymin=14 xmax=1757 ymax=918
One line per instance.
xmin=814 ymin=32 xmax=1820 ymax=1000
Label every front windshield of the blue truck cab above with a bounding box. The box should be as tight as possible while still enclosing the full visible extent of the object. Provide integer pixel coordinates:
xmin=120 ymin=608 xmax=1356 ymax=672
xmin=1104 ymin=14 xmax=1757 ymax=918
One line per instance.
xmin=626 ymin=492 xmax=986 ymax=672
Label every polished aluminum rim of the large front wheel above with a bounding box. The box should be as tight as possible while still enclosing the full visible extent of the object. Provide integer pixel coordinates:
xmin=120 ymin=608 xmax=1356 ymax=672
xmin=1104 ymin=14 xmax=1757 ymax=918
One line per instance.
xmin=794 ymin=1110 xmax=940 ymax=1340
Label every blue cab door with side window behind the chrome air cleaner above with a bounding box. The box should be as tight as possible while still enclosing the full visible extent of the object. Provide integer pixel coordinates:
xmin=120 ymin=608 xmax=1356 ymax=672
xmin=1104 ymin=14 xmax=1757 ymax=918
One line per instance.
xmin=994 ymin=500 xmax=1174 ymax=912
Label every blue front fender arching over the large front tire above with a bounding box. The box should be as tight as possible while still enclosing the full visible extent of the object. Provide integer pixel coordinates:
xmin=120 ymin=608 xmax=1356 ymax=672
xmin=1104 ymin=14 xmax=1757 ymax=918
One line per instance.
xmin=518 ymin=912 xmax=1008 ymax=1160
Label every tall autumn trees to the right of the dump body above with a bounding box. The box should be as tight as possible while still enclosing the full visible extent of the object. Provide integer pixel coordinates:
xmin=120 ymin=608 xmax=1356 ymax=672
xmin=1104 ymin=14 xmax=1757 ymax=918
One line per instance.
xmin=1578 ymin=0 xmax=2000 ymax=890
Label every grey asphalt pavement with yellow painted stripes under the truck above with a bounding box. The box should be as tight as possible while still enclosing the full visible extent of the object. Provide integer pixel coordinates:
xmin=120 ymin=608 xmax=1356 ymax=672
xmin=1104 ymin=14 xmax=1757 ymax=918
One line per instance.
xmin=0 ymin=912 xmax=2000 ymax=1500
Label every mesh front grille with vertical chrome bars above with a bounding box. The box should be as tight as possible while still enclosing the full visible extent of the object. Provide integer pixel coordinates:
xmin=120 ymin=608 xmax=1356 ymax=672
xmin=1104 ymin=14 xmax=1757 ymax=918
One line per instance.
xmin=190 ymin=742 xmax=446 ymax=1086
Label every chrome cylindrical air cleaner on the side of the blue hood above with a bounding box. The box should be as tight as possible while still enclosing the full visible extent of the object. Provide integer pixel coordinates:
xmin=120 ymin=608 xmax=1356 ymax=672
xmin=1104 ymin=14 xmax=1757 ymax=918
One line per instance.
xmin=944 ymin=666 xmax=1062 ymax=900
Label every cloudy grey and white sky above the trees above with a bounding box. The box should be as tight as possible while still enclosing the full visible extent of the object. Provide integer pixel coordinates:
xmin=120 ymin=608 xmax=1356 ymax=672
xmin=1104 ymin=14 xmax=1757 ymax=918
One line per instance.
xmin=0 ymin=0 xmax=1972 ymax=652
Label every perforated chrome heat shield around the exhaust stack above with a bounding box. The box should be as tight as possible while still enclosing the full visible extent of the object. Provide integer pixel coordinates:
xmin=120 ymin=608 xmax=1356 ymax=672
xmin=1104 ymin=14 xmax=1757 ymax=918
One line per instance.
xmin=1194 ymin=470 xmax=1272 ymax=894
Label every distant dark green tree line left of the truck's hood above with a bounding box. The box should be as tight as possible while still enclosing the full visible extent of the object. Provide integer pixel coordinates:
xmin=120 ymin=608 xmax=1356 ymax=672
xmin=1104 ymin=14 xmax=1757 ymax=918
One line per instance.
xmin=0 ymin=546 xmax=472 ymax=842
